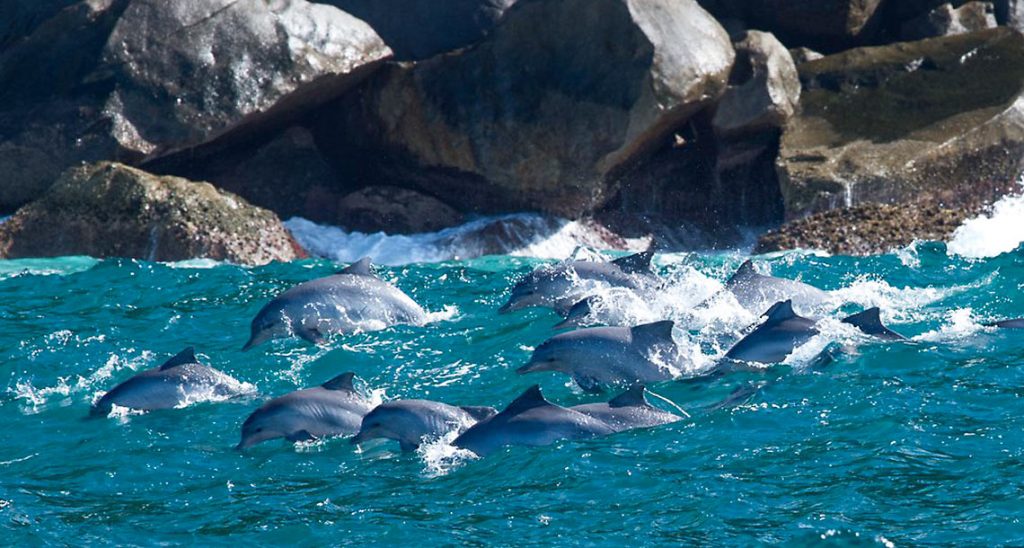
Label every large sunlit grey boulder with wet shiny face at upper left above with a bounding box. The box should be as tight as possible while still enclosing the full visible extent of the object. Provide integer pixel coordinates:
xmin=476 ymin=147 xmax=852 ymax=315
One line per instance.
xmin=103 ymin=0 xmax=391 ymax=156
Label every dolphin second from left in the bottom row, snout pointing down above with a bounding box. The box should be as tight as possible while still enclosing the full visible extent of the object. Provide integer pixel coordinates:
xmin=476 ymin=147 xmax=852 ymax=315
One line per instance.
xmin=234 ymin=373 xmax=373 ymax=451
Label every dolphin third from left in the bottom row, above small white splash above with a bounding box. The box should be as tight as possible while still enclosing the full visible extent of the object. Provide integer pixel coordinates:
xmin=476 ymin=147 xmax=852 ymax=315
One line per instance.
xmin=349 ymin=399 xmax=498 ymax=451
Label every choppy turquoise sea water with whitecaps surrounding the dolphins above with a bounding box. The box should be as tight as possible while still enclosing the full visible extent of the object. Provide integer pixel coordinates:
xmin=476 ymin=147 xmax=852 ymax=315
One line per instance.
xmin=0 ymin=198 xmax=1024 ymax=546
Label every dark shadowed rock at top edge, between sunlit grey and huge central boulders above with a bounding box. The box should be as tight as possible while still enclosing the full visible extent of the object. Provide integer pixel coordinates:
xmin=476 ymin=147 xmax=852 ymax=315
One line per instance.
xmin=319 ymin=0 xmax=515 ymax=60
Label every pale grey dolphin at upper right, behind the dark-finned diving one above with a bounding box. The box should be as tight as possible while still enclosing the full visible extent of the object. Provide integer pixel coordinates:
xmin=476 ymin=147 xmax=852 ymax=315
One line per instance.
xmin=725 ymin=260 xmax=829 ymax=312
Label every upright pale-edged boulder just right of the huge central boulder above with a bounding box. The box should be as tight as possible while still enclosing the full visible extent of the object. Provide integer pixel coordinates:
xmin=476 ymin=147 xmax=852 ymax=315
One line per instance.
xmin=712 ymin=31 xmax=800 ymax=137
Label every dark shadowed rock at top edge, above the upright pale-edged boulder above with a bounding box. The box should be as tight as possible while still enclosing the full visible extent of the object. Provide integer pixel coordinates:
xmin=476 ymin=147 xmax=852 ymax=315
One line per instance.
xmin=701 ymin=0 xmax=884 ymax=51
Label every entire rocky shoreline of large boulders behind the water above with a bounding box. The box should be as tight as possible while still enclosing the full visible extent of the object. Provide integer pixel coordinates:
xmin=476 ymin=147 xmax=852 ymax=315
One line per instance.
xmin=0 ymin=0 xmax=1024 ymax=264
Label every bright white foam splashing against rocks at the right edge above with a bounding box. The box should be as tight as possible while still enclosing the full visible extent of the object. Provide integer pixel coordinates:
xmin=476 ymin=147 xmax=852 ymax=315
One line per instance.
xmin=946 ymin=187 xmax=1024 ymax=259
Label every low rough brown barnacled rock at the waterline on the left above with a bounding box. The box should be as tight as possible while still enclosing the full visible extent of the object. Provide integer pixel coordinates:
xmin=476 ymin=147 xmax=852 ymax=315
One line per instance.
xmin=0 ymin=163 xmax=304 ymax=264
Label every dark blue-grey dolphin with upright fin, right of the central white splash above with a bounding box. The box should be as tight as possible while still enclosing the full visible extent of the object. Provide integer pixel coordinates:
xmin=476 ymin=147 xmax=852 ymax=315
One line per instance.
xmin=725 ymin=300 xmax=818 ymax=364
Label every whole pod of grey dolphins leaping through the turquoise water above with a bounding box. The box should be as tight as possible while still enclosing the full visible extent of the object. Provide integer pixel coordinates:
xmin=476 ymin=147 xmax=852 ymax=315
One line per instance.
xmin=90 ymin=251 xmax=1024 ymax=457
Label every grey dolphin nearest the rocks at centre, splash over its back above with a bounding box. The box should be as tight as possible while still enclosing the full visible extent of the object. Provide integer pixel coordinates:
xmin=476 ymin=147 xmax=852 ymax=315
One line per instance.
xmin=498 ymin=251 xmax=659 ymax=315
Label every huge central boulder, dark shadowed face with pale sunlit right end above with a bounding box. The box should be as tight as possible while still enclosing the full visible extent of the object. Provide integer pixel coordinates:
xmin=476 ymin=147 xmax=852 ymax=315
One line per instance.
xmin=322 ymin=0 xmax=733 ymax=217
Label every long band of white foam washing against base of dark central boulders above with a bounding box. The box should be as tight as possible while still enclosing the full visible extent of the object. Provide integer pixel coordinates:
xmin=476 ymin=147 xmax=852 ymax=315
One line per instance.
xmin=285 ymin=214 xmax=645 ymax=265
